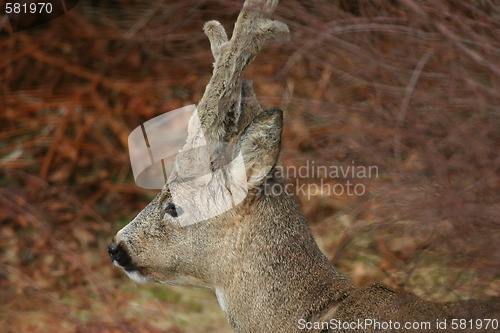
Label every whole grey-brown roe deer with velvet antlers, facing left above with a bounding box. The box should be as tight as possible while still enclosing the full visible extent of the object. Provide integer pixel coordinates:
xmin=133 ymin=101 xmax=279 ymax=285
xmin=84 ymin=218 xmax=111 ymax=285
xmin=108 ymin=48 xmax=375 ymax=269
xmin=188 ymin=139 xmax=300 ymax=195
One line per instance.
xmin=108 ymin=0 xmax=499 ymax=333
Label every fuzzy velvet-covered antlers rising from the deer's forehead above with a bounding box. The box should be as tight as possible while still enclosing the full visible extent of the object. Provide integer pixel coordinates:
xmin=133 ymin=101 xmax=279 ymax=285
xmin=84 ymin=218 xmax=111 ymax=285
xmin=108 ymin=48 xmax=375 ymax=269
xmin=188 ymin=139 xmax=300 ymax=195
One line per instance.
xmin=169 ymin=0 xmax=289 ymax=182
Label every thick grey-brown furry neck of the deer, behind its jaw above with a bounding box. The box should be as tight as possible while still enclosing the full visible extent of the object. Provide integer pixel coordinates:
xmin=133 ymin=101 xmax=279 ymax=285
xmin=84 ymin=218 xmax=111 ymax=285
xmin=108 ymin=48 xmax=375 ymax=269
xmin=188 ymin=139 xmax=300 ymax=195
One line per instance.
xmin=215 ymin=192 xmax=354 ymax=333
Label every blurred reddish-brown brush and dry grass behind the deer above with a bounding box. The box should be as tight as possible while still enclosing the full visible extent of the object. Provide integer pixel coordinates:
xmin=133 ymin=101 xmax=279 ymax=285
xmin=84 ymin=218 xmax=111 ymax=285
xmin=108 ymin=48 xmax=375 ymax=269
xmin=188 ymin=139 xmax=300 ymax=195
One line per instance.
xmin=0 ymin=0 xmax=500 ymax=333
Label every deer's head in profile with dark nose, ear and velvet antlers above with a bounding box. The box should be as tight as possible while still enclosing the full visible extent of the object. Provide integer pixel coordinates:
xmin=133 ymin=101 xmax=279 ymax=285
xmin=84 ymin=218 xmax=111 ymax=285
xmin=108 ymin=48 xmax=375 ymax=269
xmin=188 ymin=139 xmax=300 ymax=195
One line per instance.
xmin=108 ymin=0 xmax=289 ymax=288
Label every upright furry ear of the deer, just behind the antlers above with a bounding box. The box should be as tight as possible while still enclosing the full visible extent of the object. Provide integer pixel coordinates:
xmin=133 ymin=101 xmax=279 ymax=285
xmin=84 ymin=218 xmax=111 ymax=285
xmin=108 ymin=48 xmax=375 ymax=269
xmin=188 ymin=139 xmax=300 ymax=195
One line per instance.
xmin=233 ymin=108 xmax=283 ymax=189
